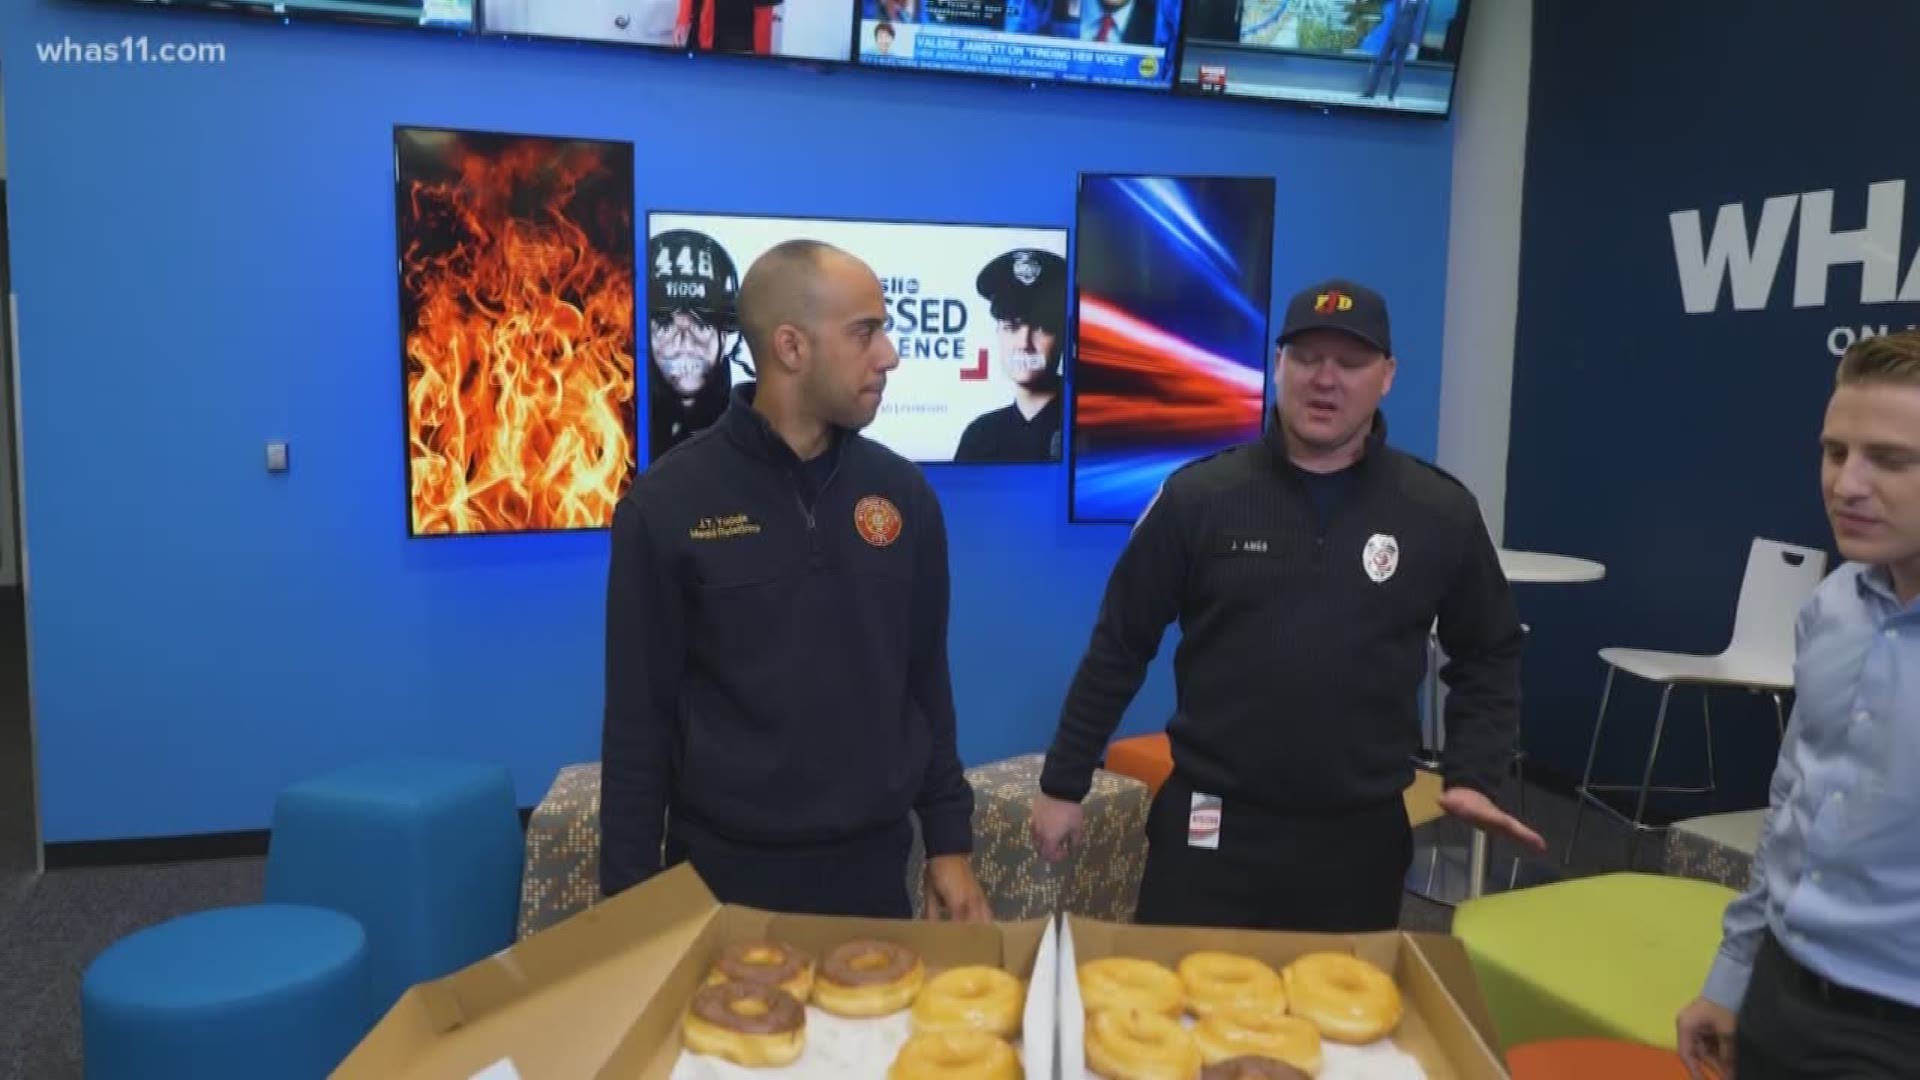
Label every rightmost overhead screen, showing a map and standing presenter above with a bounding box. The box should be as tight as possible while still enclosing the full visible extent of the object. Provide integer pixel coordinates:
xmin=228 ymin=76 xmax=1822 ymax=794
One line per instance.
xmin=1179 ymin=0 xmax=1469 ymax=115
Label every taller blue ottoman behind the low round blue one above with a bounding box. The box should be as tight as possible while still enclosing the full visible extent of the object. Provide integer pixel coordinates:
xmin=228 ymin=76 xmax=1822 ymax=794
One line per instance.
xmin=267 ymin=757 xmax=524 ymax=1013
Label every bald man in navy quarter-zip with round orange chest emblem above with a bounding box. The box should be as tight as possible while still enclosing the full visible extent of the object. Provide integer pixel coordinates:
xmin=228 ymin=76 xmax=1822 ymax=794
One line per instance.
xmin=601 ymin=240 xmax=989 ymax=920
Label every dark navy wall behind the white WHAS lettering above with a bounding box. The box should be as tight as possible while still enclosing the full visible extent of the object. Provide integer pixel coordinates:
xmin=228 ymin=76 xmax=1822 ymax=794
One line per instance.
xmin=1507 ymin=0 xmax=1920 ymax=817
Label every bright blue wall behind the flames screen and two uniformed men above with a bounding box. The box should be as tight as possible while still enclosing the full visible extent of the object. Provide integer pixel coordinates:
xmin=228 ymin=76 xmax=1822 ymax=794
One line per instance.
xmin=0 ymin=0 xmax=1452 ymax=842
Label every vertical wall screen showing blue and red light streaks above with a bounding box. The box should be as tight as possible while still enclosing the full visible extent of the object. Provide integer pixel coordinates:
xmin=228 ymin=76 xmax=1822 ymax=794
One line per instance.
xmin=1068 ymin=175 xmax=1275 ymax=523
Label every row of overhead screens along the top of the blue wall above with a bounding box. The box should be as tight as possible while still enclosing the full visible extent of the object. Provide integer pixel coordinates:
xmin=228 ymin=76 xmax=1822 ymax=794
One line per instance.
xmin=115 ymin=0 xmax=1469 ymax=115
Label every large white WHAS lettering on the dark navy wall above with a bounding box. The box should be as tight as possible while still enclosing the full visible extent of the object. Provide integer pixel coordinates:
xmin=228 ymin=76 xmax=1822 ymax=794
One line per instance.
xmin=1668 ymin=181 xmax=1920 ymax=356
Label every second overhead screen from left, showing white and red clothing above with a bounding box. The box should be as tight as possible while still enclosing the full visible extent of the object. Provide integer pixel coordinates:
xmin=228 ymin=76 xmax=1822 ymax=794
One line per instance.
xmin=480 ymin=0 xmax=854 ymax=61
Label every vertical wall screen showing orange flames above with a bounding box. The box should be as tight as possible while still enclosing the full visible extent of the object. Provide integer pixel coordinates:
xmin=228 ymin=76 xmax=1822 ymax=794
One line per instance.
xmin=394 ymin=127 xmax=637 ymax=536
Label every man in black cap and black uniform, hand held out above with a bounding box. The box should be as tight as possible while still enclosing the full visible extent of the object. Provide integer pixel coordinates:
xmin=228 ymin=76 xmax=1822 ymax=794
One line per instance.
xmin=1033 ymin=281 xmax=1544 ymax=932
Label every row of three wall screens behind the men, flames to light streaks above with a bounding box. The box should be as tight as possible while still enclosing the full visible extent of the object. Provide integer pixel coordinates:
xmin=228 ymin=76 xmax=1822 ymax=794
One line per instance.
xmin=394 ymin=127 xmax=1275 ymax=536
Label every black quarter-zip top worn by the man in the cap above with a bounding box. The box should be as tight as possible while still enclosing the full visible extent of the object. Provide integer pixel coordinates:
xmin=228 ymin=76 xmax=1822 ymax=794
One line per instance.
xmin=1041 ymin=417 xmax=1523 ymax=813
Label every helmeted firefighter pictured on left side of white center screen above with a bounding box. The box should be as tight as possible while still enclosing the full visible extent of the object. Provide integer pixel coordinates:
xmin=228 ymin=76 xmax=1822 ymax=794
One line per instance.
xmin=647 ymin=229 xmax=739 ymax=457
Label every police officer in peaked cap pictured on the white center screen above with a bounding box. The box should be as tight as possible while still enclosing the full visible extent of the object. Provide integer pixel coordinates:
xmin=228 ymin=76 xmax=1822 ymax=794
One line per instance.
xmin=954 ymin=248 xmax=1068 ymax=461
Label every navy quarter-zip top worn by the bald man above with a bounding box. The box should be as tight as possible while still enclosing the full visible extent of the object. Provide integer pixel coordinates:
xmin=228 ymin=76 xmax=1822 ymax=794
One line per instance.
xmin=601 ymin=384 xmax=973 ymax=896
